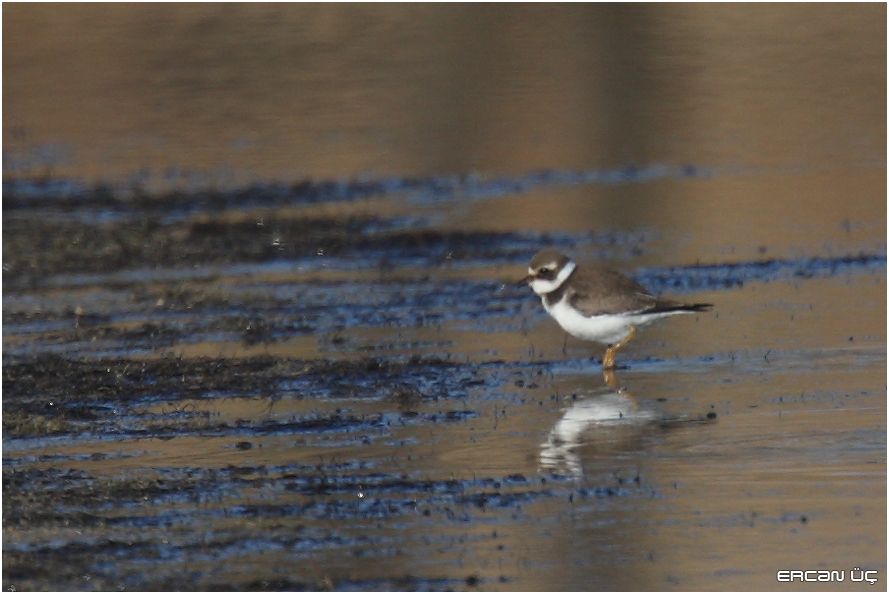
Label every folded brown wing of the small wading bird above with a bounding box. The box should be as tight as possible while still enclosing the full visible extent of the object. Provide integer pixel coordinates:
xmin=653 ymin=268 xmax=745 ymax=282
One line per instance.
xmin=567 ymin=268 xmax=658 ymax=316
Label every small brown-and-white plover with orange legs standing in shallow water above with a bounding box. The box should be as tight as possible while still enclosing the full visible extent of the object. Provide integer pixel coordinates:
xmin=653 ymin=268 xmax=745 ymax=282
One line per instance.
xmin=519 ymin=248 xmax=713 ymax=371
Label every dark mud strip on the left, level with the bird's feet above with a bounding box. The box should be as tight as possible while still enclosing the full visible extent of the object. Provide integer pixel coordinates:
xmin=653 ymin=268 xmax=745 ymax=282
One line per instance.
xmin=3 ymin=355 xmax=479 ymax=443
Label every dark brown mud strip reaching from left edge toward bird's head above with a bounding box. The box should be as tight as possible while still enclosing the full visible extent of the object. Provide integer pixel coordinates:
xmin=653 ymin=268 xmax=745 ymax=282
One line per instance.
xmin=3 ymin=217 xmax=568 ymax=285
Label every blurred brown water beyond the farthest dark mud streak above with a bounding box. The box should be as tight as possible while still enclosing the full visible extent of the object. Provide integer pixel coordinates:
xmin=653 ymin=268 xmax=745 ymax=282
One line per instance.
xmin=3 ymin=4 xmax=886 ymax=184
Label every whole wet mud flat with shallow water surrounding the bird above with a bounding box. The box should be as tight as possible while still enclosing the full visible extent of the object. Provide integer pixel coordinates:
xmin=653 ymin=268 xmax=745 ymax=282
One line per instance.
xmin=3 ymin=176 xmax=885 ymax=590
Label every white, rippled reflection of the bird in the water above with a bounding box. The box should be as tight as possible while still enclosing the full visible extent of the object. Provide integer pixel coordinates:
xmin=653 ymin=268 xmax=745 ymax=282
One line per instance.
xmin=540 ymin=370 xmax=659 ymax=478
